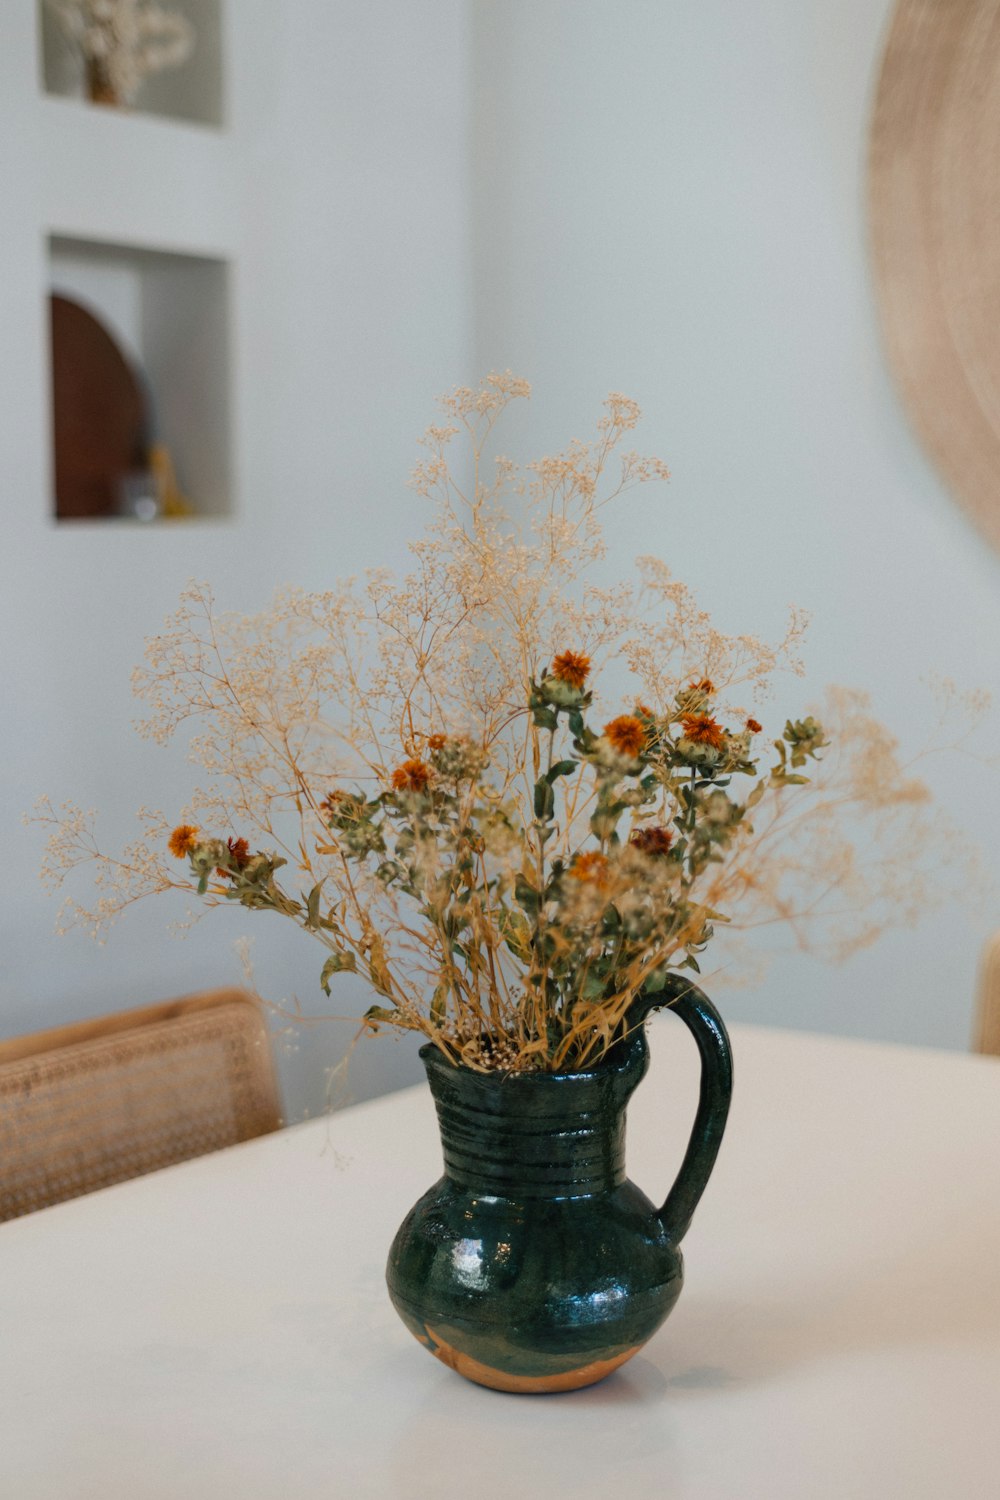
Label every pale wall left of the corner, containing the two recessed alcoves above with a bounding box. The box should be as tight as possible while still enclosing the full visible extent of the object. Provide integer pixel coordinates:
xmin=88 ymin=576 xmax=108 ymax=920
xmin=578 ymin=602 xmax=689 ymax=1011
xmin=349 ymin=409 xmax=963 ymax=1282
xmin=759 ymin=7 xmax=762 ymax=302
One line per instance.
xmin=0 ymin=0 xmax=472 ymax=1116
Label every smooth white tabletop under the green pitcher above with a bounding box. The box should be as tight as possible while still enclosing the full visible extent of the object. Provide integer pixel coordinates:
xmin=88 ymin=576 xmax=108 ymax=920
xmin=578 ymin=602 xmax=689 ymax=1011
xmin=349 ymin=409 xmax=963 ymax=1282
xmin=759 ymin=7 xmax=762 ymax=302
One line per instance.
xmin=0 ymin=1017 xmax=1000 ymax=1500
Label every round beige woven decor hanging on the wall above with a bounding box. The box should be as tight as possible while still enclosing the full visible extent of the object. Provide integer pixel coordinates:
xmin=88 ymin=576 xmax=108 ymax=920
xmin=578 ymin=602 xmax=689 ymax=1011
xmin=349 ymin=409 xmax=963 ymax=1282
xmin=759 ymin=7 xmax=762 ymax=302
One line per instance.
xmin=870 ymin=0 xmax=1000 ymax=548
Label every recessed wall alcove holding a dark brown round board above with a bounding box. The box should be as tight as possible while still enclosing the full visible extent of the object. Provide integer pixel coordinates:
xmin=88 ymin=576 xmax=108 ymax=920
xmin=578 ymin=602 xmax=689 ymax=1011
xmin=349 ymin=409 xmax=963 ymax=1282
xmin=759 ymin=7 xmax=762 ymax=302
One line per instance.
xmin=48 ymin=234 xmax=232 ymax=522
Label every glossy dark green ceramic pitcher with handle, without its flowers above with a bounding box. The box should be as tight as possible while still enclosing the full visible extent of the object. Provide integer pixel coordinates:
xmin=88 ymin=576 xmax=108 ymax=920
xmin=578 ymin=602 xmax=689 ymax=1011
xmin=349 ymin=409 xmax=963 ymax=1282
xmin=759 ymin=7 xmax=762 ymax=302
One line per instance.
xmin=387 ymin=978 xmax=732 ymax=1392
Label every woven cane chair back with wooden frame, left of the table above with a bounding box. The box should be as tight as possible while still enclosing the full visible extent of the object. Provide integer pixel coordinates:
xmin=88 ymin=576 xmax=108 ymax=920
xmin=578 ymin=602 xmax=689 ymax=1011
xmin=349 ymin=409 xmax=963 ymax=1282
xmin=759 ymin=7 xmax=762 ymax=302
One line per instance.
xmin=0 ymin=990 xmax=280 ymax=1221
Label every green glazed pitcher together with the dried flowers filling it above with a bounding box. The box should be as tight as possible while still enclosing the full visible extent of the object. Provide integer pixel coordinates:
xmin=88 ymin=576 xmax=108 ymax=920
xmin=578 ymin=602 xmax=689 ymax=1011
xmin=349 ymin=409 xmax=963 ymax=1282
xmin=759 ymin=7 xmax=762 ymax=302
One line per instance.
xmin=40 ymin=374 xmax=959 ymax=1391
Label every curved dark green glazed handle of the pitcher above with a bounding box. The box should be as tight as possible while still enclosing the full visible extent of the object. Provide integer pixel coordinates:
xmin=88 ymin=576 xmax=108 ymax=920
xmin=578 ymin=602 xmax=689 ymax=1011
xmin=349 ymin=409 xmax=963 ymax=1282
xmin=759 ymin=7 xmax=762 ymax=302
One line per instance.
xmin=637 ymin=975 xmax=733 ymax=1245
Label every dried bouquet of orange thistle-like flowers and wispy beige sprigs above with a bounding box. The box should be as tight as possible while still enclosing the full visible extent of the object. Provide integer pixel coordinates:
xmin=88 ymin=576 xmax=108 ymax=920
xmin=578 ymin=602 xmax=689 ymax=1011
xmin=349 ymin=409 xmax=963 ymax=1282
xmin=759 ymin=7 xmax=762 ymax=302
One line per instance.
xmin=42 ymin=374 xmax=959 ymax=1071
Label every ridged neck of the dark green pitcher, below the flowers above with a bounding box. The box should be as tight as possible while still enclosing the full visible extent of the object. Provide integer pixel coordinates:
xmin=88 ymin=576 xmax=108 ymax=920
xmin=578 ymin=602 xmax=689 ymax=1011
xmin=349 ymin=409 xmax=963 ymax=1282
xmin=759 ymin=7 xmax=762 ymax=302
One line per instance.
xmin=420 ymin=1029 xmax=649 ymax=1199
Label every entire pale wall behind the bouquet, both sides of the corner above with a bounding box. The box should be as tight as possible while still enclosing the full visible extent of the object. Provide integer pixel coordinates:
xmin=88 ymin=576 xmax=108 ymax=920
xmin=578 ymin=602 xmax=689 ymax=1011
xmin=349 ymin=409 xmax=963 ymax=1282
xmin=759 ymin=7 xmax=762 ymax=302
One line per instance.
xmin=7 ymin=0 xmax=1000 ymax=1116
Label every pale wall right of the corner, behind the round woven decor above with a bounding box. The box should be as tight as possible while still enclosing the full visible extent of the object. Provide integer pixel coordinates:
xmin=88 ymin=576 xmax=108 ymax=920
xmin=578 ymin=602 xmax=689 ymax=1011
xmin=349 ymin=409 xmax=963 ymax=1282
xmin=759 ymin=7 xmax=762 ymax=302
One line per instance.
xmin=474 ymin=0 xmax=1000 ymax=1047
